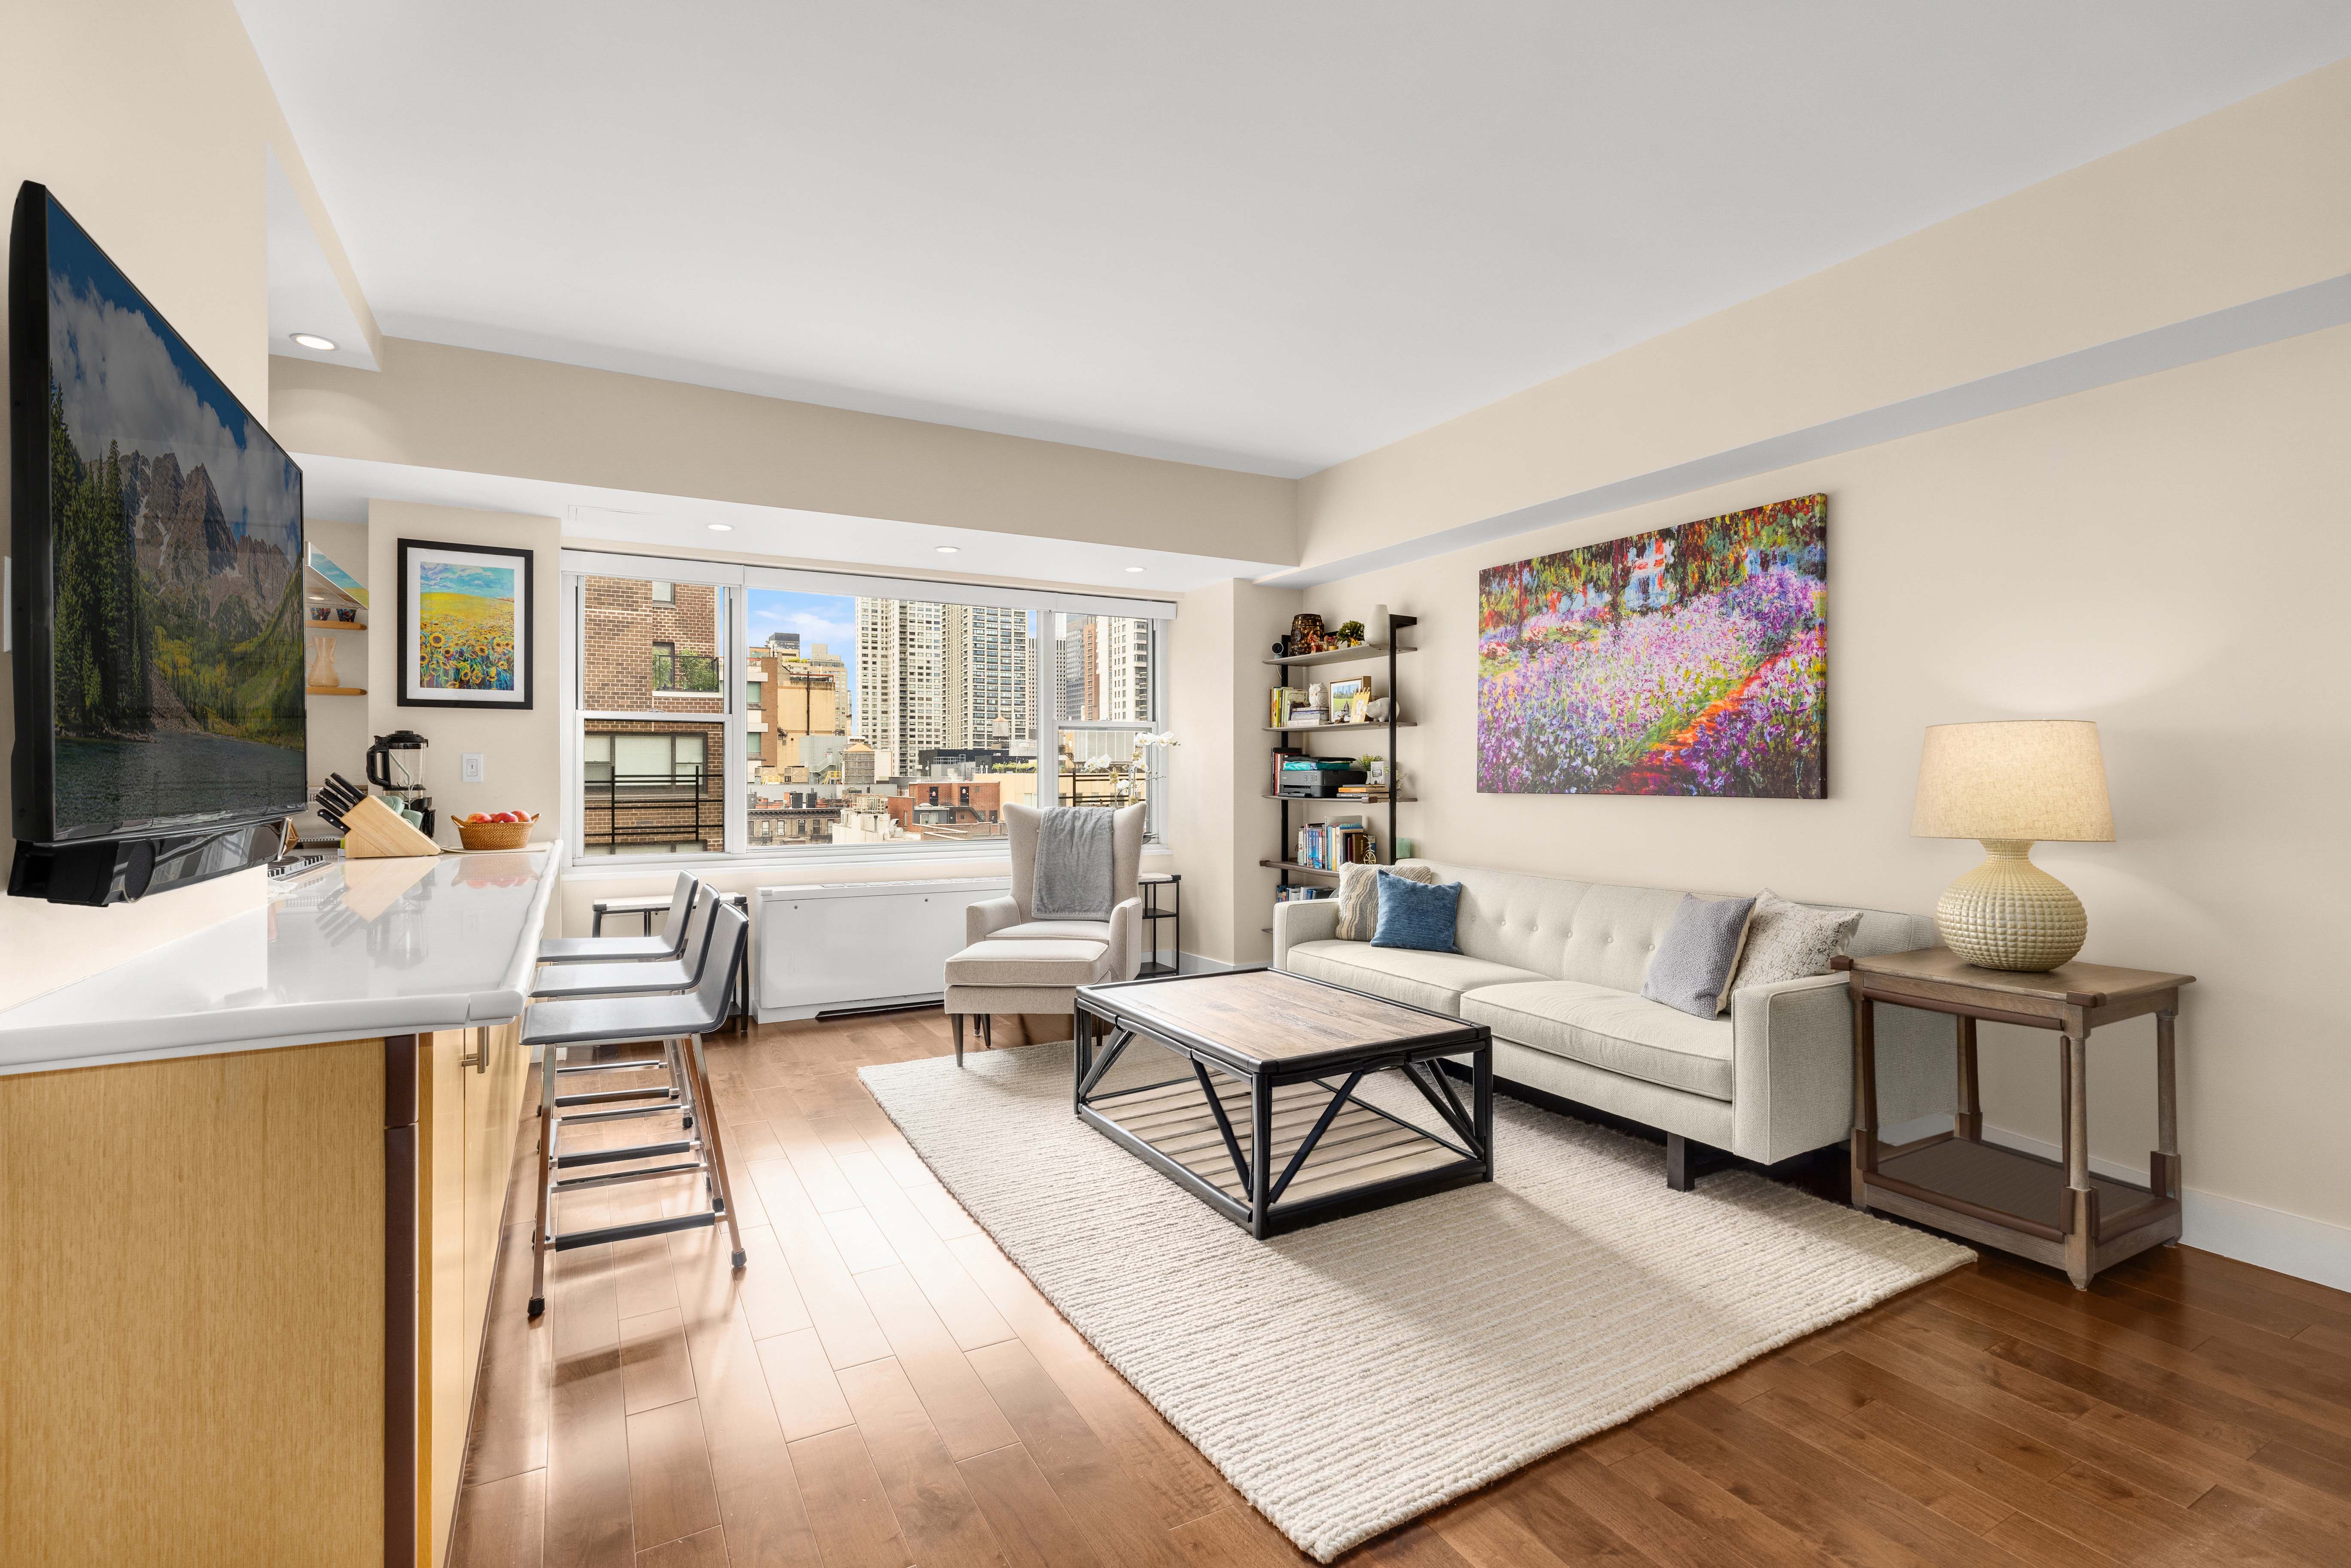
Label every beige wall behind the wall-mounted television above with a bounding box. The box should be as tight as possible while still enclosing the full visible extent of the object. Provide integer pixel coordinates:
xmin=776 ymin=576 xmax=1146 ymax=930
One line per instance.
xmin=0 ymin=0 xmax=308 ymax=1006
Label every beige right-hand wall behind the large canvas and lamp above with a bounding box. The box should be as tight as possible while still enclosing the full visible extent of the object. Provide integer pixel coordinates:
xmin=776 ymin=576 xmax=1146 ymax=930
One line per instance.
xmin=1279 ymin=327 xmax=2351 ymax=1225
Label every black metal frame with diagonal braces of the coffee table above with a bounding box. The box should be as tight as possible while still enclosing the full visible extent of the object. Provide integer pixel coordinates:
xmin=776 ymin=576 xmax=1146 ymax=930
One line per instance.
xmin=1070 ymin=964 xmax=1493 ymax=1241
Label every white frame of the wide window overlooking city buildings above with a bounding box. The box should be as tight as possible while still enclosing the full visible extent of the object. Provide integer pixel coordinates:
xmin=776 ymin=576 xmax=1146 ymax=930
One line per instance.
xmin=560 ymin=548 xmax=1176 ymax=875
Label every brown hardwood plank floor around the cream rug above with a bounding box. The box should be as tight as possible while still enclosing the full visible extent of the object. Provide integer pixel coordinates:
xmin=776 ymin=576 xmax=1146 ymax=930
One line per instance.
xmin=454 ymin=1013 xmax=2351 ymax=1568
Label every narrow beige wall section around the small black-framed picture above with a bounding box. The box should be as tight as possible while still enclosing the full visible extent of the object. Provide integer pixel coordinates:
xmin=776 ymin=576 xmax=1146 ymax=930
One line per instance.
xmin=369 ymin=501 xmax=571 ymax=849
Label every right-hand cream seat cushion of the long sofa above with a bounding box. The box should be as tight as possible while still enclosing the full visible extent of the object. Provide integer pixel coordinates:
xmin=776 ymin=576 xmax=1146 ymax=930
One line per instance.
xmin=1460 ymin=980 xmax=1731 ymax=1100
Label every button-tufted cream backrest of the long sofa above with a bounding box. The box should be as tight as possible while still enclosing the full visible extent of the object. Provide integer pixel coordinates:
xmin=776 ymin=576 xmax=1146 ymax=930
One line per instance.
xmin=1392 ymin=860 xmax=1935 ymax=992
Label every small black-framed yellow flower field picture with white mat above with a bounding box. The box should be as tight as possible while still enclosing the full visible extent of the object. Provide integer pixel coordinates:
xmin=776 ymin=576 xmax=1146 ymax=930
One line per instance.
xmin=397 ymin=538 xmax=531 ymax=708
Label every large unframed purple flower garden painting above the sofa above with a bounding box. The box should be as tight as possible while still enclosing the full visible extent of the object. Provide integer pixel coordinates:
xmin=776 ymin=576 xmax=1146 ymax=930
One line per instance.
xmin=1476 ymin=496 xmax=1829 ymax=799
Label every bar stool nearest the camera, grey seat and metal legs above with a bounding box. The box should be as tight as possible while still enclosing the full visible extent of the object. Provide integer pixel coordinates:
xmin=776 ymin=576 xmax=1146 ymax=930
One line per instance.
xmin=522 ymin=898 xmax=750 ymax=1316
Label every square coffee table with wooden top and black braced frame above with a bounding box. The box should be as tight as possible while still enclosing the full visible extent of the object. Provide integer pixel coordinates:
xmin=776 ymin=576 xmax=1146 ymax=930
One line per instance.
xmin=1072 ymin=966 xmax=1493 ymax=1241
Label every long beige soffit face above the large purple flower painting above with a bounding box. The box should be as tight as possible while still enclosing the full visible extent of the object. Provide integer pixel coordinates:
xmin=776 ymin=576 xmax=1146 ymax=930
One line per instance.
xmin=1296 ymin=61 xmax=2351 ymax=583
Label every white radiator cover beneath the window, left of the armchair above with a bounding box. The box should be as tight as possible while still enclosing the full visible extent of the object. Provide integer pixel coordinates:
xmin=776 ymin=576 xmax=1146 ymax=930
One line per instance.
xmin=752 ymin=877 xmax=1013 ymax=1023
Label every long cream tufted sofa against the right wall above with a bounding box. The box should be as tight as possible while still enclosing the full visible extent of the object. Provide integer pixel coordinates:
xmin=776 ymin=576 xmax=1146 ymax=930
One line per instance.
xmin=1274 ymin=863 xmax=1956 ymax=1189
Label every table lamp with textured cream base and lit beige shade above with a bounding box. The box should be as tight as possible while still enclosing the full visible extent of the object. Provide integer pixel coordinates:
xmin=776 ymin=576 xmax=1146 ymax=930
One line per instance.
xmin=1911 ymin=719 xmax=2114 ymax=973
